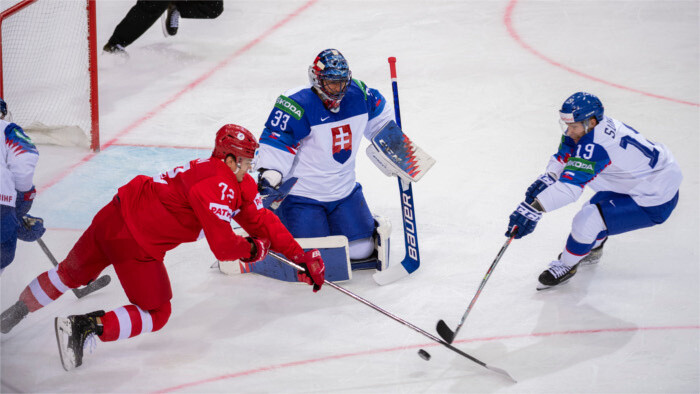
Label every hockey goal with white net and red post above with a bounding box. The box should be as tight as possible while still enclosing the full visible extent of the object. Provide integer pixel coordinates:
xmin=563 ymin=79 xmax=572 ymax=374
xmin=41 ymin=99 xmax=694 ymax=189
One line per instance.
xmin=0 ymin=0 xmax=100 ymax=151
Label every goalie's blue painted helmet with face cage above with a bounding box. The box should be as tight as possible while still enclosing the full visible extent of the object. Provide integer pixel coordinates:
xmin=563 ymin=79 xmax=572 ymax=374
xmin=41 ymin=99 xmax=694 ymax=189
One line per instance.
xmin=309 ymin=49 xmax=352 ymax=112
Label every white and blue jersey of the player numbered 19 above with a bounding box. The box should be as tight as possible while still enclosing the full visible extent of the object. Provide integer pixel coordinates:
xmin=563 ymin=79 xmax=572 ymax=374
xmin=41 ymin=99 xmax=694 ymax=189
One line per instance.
xmin=537 ymin=116 xmax=683 ymax=212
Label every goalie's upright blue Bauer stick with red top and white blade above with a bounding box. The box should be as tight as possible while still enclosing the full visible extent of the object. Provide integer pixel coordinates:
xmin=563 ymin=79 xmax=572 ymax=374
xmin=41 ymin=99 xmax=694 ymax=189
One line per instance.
xmin=372 ymin=56 xmax=420 ymax=285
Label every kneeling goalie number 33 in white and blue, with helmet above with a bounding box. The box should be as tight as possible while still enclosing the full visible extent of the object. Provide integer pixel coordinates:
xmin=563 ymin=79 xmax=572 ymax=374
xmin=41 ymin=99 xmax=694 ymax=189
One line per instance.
xmin=255 ymin=49 xmax=394 ymax=268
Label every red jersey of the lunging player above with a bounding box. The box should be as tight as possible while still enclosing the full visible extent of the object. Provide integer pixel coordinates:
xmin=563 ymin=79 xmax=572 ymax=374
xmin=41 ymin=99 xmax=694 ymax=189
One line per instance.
xmin=117 ymin=158 xmax=303 ymax=261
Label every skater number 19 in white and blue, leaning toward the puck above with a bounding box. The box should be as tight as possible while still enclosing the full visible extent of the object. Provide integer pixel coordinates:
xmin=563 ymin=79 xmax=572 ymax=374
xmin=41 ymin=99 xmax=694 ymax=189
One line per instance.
xmin=506 ymin=92 xmax=683 ymax=289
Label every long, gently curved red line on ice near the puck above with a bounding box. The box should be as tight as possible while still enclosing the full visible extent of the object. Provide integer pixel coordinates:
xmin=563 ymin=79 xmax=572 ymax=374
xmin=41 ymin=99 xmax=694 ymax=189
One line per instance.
xmin=155 ymin=325 xmax=700 ymax=393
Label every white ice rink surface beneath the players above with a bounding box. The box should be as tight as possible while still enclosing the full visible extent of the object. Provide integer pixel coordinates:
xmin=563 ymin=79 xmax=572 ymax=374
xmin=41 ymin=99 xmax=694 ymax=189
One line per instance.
xmin=0 ymin=0 xmax=700 ymax=393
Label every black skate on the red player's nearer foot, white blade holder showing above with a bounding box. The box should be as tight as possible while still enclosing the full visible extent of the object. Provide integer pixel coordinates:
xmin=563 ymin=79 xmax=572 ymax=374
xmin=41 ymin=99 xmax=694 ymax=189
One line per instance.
xmin=55 ymin=311 xmax=105 ymax=371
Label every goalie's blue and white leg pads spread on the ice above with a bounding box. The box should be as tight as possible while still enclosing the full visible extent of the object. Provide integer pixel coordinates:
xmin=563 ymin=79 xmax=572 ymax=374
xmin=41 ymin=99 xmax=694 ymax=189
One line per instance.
xmin=218 ymin=216 xmax=391 ymax=282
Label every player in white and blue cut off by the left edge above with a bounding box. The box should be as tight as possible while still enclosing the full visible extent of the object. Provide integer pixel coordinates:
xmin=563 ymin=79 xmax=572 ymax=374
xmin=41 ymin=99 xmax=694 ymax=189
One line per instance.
xmin=0 ymin=98 xmax=45 ymax=274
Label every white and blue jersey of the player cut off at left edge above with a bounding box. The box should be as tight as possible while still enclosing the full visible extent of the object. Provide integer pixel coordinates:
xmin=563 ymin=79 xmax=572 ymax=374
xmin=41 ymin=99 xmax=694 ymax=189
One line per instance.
xmin=0 ymin=120 xmax=39 ymax=207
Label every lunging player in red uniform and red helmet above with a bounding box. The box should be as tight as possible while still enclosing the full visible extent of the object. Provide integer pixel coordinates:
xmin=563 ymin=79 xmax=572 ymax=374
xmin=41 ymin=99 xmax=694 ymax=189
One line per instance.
xmin=2 ymin=124 xmax=325 ymax=370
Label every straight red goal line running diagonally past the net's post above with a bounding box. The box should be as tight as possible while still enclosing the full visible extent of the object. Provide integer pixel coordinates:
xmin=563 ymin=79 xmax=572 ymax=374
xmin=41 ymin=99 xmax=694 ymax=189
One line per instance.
xmin=41 ymin=0 xmax=318 ymax=195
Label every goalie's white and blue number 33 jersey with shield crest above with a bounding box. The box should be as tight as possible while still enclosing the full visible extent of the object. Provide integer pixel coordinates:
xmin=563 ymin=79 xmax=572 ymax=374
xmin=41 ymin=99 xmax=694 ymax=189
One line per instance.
xmin=255 ymin=79 xmax=394 ymax=202
